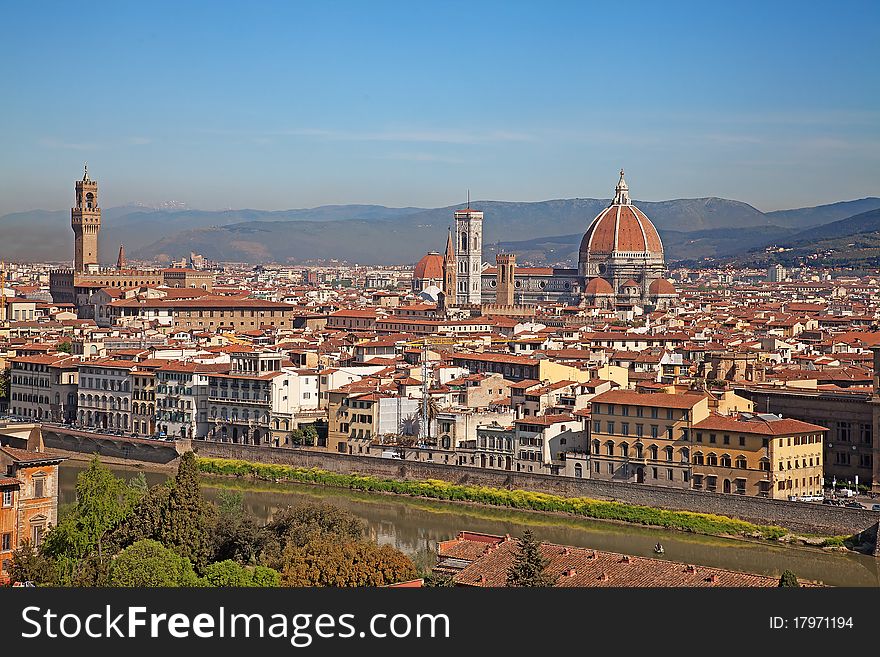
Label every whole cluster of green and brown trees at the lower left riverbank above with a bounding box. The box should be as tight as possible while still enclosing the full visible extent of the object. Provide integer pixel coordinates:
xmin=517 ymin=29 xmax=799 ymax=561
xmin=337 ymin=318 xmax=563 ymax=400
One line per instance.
xmin=12 ymin=452 xmax=416 ymax=587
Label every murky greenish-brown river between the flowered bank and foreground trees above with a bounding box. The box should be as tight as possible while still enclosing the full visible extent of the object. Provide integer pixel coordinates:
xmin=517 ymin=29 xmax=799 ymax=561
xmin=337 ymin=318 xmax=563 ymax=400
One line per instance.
xmin=59 ymin=462 xmax=880 ymax=586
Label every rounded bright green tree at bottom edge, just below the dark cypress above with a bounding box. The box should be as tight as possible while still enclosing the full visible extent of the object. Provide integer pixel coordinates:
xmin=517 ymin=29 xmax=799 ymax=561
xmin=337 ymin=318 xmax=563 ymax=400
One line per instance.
xmin=110 ymin=539 xmax=202 ymax=587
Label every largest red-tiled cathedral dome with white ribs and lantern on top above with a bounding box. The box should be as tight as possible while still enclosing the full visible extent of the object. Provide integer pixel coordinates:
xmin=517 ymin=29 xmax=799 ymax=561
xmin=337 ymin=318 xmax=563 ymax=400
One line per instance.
xmin=580 ymin=169 xmax=663 ymax=262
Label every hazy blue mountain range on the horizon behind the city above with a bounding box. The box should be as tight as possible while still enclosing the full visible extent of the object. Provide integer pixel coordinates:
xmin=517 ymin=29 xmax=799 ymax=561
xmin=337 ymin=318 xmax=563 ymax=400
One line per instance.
xmin=0 ymin=197 xmax=880 ymax=265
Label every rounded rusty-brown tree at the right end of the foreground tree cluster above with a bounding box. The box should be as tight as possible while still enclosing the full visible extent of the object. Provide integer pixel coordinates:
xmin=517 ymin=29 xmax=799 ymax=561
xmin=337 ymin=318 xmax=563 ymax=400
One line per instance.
xmin=281 ymin=537 xmax=416 ymax=586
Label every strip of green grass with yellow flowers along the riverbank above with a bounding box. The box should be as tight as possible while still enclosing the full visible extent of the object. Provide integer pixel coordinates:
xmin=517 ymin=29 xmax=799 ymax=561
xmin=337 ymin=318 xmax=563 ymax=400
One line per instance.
xmin=198 ymin=457 xmax=788 ymax=539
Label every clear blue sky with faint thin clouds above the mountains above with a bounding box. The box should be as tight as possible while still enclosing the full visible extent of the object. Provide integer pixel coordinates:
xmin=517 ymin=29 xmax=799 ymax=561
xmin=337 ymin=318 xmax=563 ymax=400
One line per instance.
xmin=0 ymin=0 xmax=880 ymax=213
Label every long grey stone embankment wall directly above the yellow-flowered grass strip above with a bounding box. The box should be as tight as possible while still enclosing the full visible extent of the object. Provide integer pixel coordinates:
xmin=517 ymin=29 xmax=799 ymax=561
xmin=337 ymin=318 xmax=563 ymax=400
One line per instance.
xmin=192 ymin=441 xmax=880 ymax=535
